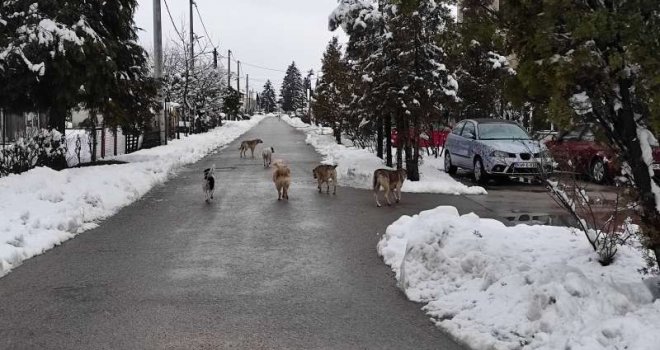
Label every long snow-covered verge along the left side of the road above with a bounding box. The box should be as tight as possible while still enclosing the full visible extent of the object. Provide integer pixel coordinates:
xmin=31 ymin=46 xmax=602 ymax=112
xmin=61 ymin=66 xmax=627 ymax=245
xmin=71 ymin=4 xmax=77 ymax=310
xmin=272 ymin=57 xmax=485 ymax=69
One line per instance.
xmin=0 ymin=116 xmax=264 ymax=276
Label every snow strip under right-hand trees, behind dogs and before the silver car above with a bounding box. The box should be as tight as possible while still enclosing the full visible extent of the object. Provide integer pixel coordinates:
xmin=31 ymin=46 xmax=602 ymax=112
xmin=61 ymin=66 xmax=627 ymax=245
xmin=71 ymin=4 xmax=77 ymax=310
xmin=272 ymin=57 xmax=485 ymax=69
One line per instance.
xmin=282 ymin=115 xmax=486 ymax=194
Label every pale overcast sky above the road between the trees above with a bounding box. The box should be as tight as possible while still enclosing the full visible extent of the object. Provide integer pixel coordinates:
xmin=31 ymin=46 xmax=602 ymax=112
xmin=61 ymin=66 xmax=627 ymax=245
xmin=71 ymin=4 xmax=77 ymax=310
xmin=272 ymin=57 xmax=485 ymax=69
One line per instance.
xmin=135 ymin=0 xmax=345 ymax=92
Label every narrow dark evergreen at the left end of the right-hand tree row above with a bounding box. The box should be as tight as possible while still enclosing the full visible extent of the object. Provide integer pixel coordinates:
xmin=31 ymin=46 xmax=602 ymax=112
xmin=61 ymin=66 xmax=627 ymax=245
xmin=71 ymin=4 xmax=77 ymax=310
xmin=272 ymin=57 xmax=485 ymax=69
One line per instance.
xmin=312 ymin=37 xmax=348 ymax=143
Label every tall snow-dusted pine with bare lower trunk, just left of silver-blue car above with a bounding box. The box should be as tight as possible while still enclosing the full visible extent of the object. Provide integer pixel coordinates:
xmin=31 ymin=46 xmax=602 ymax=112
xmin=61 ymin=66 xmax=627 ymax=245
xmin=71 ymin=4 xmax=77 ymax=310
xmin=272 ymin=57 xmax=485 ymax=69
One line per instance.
xmin=384 ymin=0 xmax=458 ymax=181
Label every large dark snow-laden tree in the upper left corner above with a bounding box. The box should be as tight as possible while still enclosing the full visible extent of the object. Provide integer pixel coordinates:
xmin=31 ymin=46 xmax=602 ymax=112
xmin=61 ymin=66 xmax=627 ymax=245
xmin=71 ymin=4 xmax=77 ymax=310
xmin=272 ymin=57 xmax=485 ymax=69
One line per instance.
xmin=0 ymin=0 xmax=155 ymax=132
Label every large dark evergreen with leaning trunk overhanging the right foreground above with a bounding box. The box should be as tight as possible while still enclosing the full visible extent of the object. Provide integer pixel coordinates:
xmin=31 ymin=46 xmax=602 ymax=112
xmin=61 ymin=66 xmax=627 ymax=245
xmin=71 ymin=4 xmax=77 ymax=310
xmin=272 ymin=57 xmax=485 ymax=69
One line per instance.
xmin=501 ymin=0 xmax=660 ymax=262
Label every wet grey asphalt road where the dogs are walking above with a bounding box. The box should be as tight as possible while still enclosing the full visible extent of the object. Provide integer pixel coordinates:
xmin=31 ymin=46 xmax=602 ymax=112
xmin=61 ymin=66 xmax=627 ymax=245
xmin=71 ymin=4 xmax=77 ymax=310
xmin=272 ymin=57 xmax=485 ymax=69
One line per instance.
xmin=0 ymin=118 xmax=492 ymax=349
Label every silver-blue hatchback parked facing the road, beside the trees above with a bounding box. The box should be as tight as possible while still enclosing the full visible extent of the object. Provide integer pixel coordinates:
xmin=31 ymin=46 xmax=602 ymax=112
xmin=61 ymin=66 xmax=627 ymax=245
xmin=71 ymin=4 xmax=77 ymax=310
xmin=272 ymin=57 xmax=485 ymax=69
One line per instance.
xmin=445 ymin=119 xmax=553 ymax=183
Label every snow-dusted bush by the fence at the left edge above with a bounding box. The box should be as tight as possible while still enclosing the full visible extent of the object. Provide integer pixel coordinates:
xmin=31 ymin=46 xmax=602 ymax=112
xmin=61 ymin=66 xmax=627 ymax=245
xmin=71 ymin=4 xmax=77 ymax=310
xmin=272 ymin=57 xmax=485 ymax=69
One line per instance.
xmin=0 ymin=129 xmax=67 ymax=176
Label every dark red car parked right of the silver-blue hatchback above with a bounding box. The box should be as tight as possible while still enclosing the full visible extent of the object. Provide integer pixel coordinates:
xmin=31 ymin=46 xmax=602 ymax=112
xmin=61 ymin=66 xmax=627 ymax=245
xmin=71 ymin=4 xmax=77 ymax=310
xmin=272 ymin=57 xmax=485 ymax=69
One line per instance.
xmin=545 ymin=125 xmax=660 ymax=184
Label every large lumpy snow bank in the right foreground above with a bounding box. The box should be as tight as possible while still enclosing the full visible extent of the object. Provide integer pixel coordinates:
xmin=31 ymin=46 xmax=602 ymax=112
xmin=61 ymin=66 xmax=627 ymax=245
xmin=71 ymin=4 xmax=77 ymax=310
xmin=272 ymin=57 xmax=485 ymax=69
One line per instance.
xmin=378 ymin=207 xmax=660 ymax=350
